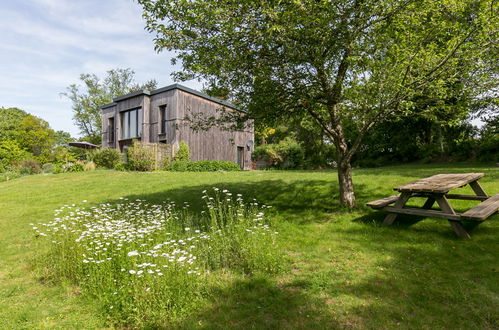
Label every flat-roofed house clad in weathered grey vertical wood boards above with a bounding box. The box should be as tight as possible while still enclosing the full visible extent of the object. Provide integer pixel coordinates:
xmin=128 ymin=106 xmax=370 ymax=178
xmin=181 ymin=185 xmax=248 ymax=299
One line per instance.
xmin=101 ymin=84 xmax=254 ymax=169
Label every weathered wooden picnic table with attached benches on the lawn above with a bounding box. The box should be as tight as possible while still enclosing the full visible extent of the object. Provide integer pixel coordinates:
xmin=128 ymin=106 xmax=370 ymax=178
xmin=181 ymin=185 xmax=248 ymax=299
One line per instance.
xmin=367 ymin=173 xmax=499 ymax=238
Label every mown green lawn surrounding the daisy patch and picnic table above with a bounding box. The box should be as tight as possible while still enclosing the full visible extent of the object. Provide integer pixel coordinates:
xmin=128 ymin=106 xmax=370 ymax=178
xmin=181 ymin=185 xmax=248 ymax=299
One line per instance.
xmin=0 ymin=164 xmax=499 ymax=329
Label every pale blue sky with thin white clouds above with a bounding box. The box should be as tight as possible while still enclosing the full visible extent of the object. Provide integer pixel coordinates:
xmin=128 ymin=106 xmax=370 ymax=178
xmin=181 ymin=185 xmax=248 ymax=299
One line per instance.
xmin=0 ymin=0 xmax=202 ymax=137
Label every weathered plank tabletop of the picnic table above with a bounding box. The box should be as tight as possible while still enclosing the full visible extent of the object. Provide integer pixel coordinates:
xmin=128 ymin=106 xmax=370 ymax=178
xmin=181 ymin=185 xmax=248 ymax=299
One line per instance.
xmin=393 ymin=173 xmax=485 ymax=194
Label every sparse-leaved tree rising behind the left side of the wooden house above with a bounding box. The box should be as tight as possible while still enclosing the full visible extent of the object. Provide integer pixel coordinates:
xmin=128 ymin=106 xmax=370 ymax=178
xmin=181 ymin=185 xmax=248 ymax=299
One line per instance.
xmin=62 ymin=68 xmax=157 ymax=144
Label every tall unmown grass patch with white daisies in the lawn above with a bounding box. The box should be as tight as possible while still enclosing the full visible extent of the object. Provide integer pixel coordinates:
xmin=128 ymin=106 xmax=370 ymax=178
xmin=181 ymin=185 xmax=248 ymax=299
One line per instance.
xmin=33 ymin=188 xmax=281 ymax=326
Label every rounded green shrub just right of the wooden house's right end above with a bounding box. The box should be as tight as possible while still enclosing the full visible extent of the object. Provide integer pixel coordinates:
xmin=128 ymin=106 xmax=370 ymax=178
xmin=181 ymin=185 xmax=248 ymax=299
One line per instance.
xmin=252 ymin=137 xmax=305 ymax=169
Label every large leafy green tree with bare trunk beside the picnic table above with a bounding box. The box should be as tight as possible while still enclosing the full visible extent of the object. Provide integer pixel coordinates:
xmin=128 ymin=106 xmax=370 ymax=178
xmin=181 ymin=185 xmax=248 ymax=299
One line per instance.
xmin=138 ymin=0 xmax=499 ymax=207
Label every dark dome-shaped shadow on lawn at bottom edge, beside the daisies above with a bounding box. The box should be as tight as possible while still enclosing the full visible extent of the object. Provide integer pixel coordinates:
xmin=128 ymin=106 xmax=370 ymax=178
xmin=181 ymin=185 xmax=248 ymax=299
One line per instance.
xmin=175 ymin=277 xmax=339 ymax=329
